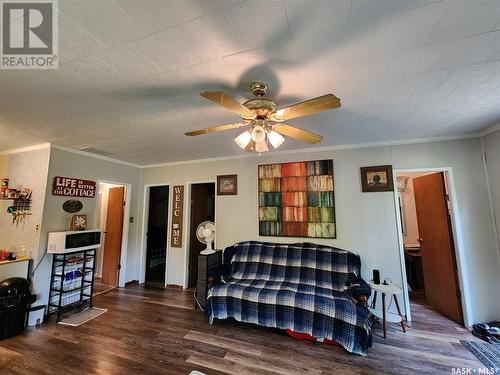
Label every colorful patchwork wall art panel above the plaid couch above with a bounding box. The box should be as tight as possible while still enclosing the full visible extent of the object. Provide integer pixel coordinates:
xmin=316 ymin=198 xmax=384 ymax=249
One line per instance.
xmin=259 ymin=160 xmax=336 ymax=238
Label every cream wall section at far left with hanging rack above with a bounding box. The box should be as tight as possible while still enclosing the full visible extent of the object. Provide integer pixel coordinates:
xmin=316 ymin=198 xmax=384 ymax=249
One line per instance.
xmin=0 ymin=146 xmax=50 ymax=262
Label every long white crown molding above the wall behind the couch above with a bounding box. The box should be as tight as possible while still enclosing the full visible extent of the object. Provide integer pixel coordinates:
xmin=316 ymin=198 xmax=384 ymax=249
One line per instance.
xmin=139 ymin=133 xmax=481 ymax=169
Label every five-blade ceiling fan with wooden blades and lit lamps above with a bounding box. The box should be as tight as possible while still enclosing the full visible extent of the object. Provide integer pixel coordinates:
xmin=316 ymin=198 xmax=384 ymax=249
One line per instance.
xmin=185 ymin=82 xmax=340 ymax=153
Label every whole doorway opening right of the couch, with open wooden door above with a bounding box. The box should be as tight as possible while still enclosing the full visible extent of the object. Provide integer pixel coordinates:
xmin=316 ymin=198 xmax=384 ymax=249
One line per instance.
xmin=396 ymin=171 xmax=464 ymax=324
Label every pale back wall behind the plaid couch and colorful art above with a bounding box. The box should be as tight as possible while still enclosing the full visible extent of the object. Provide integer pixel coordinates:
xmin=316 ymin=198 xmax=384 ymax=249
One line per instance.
xmin=140 ymin=139 xmax=500 ymax=322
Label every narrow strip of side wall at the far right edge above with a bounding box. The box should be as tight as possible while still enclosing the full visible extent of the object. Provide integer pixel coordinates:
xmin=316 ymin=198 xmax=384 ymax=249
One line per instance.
xmin=482 ymin=130 xmax=500 ymax=294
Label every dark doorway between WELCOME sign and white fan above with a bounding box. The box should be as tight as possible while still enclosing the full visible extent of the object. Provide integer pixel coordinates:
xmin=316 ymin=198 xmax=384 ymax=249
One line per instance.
xmin=187 ymin=182 xmax=215 ymax=288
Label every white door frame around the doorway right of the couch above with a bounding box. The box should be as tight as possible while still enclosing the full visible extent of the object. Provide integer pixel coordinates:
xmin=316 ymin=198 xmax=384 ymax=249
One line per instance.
xmin=392 ymin=167 xmax=472 ymax=327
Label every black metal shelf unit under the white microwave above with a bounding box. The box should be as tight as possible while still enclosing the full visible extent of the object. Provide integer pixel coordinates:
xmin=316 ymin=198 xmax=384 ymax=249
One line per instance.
xmin=47 ymin=249 xmax=96 ymax=321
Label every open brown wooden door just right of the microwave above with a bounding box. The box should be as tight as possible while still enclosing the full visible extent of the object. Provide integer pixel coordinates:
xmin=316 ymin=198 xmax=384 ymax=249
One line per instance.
xmin=102 ymin=186 xmax=125 ymax=285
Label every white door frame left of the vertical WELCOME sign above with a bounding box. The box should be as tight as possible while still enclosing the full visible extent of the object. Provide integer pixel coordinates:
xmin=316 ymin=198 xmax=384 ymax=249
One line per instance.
xmin=139 ymin=182 xmax=172 ymax=286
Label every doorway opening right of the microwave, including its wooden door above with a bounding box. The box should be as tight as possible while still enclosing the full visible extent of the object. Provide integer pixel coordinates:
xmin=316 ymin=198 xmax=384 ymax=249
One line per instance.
xmin=96 ymin=182 xmax=127 ymax=289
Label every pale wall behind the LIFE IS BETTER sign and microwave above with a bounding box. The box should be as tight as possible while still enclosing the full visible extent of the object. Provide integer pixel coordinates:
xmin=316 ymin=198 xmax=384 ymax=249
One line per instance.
xmin=34 ymin=148 xmax=141 ymax=305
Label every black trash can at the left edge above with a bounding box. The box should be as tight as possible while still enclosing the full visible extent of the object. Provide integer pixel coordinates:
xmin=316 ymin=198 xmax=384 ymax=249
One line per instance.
xmin=0 ymin=277 xmax=36 ymax=340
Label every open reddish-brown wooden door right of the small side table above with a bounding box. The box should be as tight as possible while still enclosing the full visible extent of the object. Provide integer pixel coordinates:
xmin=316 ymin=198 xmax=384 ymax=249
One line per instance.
xmin=413 ymin=173 xmax=463 ymax=324
